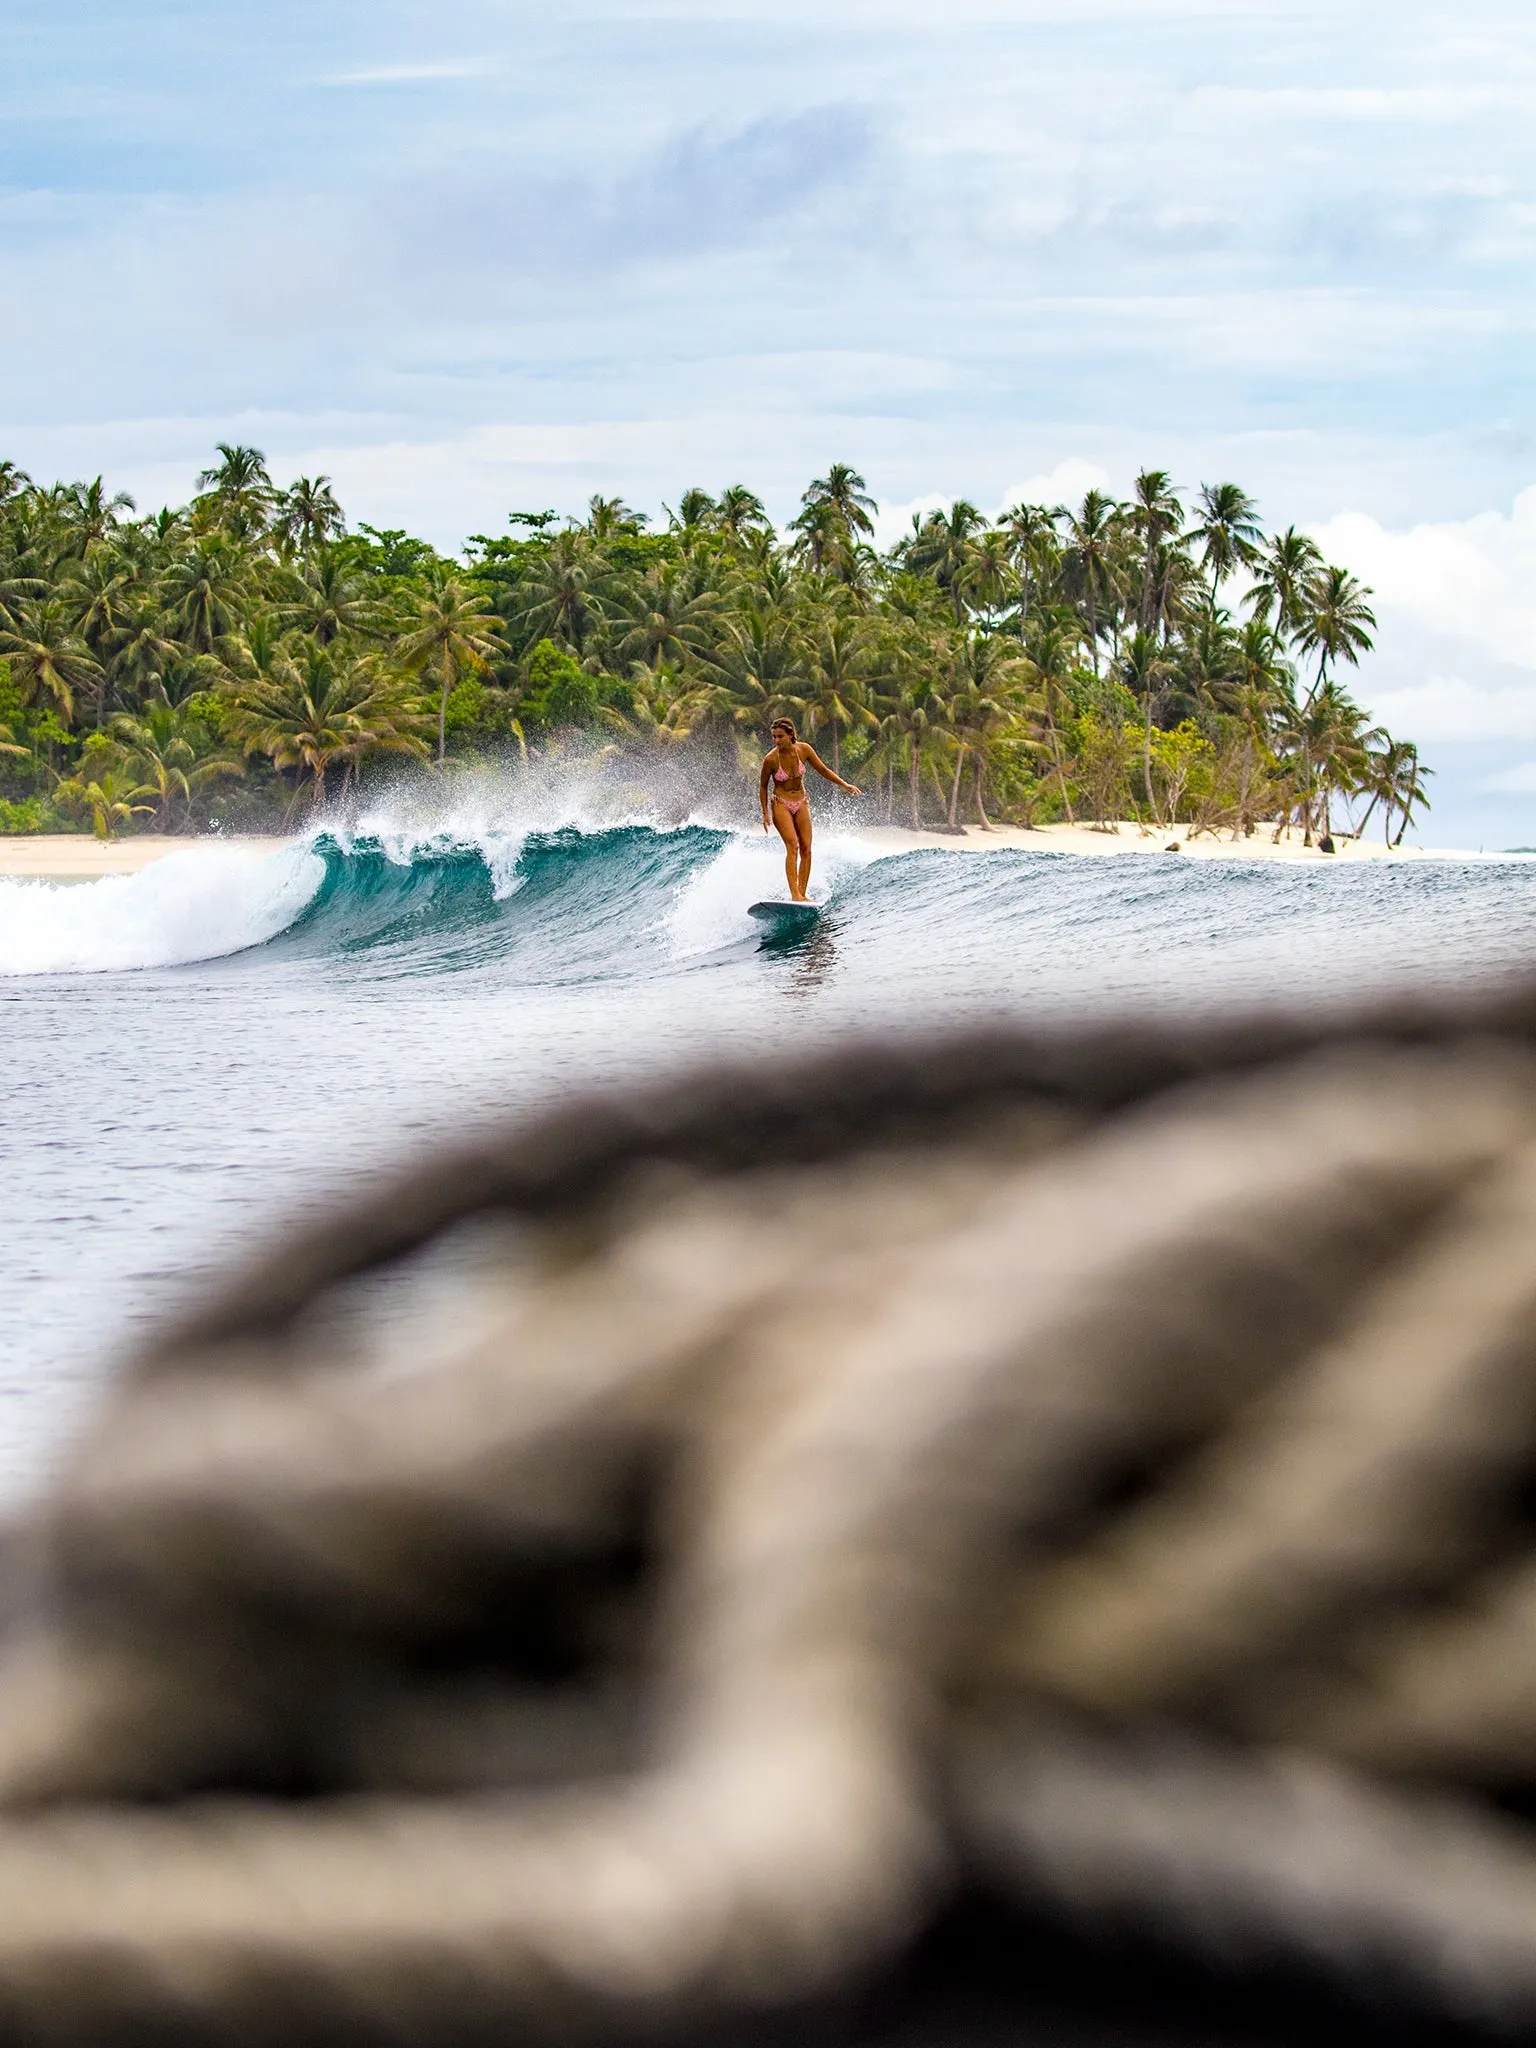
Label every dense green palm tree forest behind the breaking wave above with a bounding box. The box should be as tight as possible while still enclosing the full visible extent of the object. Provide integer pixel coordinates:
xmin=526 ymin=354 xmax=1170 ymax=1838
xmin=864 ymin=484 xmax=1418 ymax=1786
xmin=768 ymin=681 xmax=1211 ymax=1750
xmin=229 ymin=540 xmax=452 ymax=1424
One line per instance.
xmin=0 ymin=454 xmax=1430 ymax=846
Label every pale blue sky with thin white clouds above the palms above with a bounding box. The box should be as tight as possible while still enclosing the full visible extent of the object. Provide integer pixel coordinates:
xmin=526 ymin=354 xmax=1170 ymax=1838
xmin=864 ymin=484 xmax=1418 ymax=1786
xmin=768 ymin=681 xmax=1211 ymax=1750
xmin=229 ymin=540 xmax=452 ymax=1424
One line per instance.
xmin=0 ymin=0 xmax=1536 ymax=846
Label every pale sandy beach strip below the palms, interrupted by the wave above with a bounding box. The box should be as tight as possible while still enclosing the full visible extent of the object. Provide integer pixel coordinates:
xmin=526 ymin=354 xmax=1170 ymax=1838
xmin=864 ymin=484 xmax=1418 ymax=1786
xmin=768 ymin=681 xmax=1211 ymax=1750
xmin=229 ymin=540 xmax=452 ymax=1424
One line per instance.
xmin=0 ymin=821 xmax=1507 ymax=883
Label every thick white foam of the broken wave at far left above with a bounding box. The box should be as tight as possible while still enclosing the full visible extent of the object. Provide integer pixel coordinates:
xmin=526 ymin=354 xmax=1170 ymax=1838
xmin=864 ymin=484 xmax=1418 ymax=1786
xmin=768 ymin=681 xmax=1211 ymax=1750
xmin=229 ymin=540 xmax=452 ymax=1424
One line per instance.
xmin=0 ymin=846 xmax=326 ymax=975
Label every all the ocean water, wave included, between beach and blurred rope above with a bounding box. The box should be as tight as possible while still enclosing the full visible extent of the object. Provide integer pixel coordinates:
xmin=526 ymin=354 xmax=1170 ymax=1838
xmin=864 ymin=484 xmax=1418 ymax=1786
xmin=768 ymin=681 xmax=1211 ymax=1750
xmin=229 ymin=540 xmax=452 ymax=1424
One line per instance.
xmin=0 ymin=803 xmax=1536 ymax=1497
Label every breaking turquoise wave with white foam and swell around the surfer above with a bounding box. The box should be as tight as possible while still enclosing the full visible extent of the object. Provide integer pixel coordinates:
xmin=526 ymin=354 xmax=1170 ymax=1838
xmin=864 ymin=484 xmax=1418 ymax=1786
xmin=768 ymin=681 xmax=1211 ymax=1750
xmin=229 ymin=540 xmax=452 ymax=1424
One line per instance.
xmin=0 ymin=815 xmax=1532 ymax=1006
